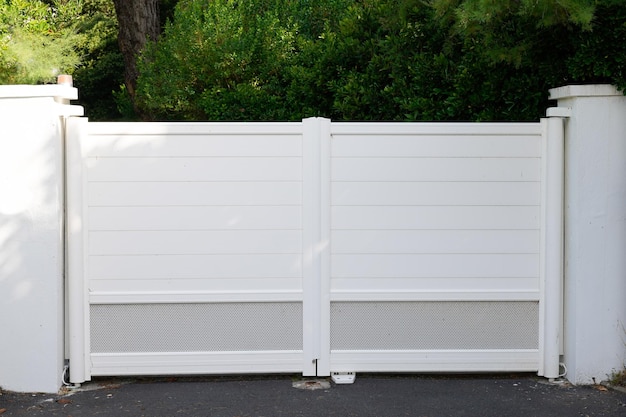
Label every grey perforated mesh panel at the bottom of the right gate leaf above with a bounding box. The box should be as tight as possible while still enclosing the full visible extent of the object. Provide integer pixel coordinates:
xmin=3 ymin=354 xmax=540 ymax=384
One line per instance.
xmin=330 ymin=301 xmax=539 ymax=350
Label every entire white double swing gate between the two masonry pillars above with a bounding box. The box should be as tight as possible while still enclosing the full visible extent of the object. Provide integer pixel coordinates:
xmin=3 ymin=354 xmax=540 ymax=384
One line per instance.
xmin=66 ymin=118 xmax=563 ymax=383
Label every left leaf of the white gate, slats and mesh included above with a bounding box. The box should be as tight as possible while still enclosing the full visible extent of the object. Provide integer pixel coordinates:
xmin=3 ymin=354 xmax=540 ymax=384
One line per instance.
xmin=70 ymin=123 xmax=303 ymax=379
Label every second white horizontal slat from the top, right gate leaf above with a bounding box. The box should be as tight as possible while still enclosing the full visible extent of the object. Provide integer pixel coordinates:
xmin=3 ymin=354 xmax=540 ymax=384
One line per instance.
xmin=331 ymin=158 xmax=541 ymax=182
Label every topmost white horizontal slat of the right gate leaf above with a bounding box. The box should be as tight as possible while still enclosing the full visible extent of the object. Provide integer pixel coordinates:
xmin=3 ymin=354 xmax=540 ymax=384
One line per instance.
xmin=331 ymin=134 xmax=541 ymax=158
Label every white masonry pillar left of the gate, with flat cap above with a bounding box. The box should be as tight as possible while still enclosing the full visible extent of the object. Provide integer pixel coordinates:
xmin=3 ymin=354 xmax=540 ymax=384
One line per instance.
xmin=0 ymin=85 xmax=77 ymax=392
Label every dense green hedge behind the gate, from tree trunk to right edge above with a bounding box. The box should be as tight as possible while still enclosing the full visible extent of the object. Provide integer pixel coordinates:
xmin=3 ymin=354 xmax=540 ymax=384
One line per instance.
xmin=138 ymin=0 xmax=626 ymax=120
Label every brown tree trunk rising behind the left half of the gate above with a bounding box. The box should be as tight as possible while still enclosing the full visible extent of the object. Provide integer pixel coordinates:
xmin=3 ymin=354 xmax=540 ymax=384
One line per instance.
xmin=113 ymin=0 xmax=161 ymax=100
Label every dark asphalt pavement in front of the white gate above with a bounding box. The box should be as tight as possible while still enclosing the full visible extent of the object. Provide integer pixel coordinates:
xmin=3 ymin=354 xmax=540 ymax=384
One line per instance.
xmin=0 ymin=374 xmax=626 ymax=417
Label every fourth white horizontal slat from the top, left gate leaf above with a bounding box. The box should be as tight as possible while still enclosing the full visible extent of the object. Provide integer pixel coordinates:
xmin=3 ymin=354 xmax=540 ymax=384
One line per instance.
xmin=88 ymin=206 xmax=302 ymax=230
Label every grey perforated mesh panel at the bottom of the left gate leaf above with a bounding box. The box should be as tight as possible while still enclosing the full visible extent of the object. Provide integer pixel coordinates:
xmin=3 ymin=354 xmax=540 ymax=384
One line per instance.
xmin=90 ymin=303 xmax=302 ymax=353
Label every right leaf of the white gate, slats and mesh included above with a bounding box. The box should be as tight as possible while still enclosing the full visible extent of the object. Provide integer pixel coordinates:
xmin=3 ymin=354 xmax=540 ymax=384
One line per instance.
xmin=329 ymin=123 xmax=542 ymax=372
